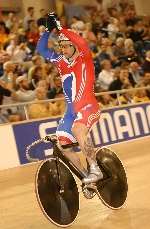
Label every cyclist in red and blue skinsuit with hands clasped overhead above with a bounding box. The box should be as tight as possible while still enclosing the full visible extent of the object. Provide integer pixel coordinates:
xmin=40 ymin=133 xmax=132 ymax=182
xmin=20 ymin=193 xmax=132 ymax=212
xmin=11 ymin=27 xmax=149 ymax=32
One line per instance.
xmin=37 ymin=13 xmax=103 ymax=184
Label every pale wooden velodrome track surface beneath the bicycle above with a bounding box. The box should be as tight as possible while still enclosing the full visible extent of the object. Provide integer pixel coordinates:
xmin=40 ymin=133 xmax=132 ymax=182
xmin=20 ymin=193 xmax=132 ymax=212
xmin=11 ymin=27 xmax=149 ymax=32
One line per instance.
xmin=0 ymin=137 xmax=150 ymax=229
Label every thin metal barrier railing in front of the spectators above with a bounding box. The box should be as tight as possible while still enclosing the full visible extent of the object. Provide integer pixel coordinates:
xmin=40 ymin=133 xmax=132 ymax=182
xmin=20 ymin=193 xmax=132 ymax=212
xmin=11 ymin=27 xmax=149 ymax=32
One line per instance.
xmin=0 ymin=86 xmax=150 ymax=120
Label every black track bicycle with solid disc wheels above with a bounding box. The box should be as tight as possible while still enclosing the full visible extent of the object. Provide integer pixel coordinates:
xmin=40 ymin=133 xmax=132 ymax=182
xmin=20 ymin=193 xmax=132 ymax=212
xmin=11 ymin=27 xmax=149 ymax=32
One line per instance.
xmin=26 ymin=135 xmax=128 ymax=227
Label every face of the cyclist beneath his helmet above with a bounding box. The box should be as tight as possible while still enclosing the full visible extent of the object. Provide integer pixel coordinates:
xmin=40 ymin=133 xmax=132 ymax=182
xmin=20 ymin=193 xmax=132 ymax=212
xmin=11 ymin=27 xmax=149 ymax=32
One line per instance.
xmin=59 ymin=41 xmax=75 ymax=59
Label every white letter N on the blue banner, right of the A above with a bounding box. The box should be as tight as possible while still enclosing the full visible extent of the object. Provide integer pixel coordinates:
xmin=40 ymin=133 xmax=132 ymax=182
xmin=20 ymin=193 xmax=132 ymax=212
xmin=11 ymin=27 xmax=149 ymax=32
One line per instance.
xmin=130 ymin=107 xmax=149 ymax=136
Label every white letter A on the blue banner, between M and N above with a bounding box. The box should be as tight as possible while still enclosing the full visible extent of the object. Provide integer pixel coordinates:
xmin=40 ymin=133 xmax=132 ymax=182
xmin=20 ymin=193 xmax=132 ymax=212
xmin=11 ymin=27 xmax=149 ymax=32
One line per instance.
xmin=113 ymin=110 xmax=134 ymax=139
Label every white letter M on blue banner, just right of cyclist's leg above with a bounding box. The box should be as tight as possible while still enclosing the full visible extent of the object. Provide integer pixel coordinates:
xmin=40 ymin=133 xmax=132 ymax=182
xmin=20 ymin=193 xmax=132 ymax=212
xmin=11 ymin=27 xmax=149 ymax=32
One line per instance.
xmin=100 ymin=113 xmax=117 ymax=143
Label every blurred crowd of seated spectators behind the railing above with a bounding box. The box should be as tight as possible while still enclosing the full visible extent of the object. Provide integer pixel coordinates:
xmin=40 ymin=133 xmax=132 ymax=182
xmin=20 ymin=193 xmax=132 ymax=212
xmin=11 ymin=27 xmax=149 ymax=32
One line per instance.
xmin=0 ymin=0 xmax=150 ymax=123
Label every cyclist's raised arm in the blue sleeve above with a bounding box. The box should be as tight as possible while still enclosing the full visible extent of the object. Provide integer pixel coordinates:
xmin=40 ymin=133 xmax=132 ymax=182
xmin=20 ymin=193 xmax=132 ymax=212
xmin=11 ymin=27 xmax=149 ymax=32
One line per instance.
xmin=36 ymin=31 xmax=60 ymax=62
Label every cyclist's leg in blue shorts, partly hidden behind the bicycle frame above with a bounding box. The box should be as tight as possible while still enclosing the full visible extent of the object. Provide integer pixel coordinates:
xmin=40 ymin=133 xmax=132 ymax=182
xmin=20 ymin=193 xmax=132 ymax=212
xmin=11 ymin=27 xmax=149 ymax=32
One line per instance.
xmin=56 ymin=113 xmax=87 ymax=175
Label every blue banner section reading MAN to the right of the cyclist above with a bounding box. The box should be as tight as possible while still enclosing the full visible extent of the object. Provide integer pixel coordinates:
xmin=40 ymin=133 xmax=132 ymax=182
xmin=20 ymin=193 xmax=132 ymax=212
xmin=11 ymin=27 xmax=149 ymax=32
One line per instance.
xmin=91 ymin=105 xmax=150 ymax=146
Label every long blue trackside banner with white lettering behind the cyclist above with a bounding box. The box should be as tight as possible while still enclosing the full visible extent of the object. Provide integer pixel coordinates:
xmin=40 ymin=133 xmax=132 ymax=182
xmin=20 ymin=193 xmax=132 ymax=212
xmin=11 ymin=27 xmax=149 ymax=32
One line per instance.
xmin=13 ymin=103 xmax=150 ymax=164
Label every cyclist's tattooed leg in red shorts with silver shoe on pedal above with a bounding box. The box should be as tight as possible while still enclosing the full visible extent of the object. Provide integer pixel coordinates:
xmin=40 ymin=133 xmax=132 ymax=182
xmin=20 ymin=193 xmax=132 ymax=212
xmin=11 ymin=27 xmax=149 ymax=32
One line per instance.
xmin=72 ymin=104 xmax=103 ymax=183
